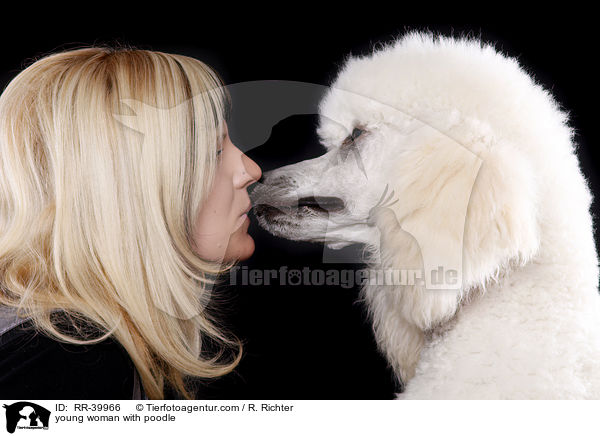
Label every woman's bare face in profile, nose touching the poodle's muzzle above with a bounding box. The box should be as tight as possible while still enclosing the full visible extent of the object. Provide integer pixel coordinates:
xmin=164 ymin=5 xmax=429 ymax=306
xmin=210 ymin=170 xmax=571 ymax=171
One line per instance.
xmin=193 ymin=126 xmax=262 ymax=262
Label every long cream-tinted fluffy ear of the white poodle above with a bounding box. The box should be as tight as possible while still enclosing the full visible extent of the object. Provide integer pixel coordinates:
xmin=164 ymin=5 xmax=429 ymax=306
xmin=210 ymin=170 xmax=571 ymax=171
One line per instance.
xmin=378 ymin=129 xmax=539 ymax=330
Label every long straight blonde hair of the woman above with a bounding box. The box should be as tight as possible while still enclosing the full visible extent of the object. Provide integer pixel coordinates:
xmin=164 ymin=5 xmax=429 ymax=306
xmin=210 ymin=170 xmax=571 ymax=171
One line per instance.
xmin=0 ymin=47 xmax=241 ymax=399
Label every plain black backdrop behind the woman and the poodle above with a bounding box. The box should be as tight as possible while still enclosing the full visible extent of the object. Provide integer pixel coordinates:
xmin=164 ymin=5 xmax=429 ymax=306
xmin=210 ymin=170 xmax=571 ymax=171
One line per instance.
xmin=0 ymin=20 xmax=600 ymax=399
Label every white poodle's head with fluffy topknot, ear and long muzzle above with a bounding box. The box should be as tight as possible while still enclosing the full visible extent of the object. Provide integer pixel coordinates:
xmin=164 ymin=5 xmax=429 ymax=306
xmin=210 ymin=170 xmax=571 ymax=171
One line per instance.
xmin=253 ymin=34 xmax=540 ymax=300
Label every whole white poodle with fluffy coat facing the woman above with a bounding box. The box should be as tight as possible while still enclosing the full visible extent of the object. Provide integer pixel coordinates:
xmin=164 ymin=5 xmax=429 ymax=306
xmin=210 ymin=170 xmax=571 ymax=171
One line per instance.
xmin=253 ymin=34 xmax=600 ymax=399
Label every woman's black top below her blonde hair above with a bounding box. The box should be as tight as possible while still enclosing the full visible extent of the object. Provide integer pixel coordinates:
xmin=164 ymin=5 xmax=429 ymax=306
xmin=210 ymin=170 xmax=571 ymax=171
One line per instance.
xmin=0 ymin=321 xmax=134 ymax=400
